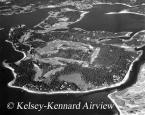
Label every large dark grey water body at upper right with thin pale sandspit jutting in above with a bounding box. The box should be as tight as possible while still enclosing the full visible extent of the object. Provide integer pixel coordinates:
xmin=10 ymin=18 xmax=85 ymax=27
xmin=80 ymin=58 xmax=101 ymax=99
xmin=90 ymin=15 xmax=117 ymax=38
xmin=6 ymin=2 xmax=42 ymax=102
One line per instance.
xmin=69 ymin=4 xmax=145 ymax=34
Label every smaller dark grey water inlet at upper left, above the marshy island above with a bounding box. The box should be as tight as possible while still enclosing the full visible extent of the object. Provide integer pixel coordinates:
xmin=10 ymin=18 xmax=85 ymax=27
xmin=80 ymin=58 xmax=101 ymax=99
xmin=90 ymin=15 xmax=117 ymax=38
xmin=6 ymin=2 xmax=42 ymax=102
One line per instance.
xmin=0 ymin=9 xmax=50 ymax=28
